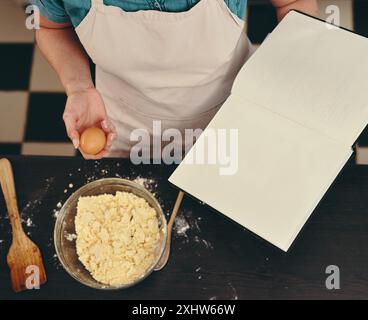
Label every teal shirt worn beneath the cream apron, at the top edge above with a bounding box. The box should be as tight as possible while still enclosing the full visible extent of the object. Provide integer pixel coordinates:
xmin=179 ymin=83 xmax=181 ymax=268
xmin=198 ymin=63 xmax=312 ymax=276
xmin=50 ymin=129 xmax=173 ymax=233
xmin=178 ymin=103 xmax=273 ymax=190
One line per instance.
xmin=30 ymin=0 xmax=247 ymax=27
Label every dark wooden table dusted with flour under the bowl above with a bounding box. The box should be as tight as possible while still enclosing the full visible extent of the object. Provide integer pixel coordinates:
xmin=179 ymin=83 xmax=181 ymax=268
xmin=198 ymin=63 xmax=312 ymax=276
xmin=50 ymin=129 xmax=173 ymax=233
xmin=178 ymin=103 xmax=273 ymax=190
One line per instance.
xmin=0 ymin=157 xmax=368 ymax=300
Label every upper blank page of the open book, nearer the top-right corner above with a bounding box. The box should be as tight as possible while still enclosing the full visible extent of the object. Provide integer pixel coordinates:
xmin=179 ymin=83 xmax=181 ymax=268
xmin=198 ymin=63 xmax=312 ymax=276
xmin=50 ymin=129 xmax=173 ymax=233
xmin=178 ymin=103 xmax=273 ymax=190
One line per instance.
xmin=233 ymin=11 xmax=368 ymax=146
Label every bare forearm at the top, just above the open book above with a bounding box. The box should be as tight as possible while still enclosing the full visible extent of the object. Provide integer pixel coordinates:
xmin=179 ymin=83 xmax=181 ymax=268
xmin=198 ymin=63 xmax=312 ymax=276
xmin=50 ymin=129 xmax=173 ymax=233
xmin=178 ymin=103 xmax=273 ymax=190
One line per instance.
xmin=271 ymin=0 xmax=318 ymax=20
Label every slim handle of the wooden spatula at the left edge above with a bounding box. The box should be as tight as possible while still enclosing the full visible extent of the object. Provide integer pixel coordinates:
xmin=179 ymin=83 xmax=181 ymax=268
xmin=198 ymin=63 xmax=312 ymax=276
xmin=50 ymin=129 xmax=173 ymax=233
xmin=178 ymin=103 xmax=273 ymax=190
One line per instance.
xmin=0 ymin=158 xmax=23 ymax=236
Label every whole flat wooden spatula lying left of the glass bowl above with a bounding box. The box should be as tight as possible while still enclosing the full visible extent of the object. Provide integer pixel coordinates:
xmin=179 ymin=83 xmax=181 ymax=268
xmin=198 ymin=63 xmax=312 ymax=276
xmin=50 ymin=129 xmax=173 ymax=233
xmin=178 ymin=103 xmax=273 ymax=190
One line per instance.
xmin=0 ymin=159 xmax=46 ymax=292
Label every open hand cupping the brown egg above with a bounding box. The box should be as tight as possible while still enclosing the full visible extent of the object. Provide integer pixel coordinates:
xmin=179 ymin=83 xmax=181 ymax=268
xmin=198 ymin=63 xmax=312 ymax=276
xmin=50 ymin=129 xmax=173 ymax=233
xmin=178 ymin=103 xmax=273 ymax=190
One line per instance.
xmin=63 ymin=88 xmax=117 ymax=160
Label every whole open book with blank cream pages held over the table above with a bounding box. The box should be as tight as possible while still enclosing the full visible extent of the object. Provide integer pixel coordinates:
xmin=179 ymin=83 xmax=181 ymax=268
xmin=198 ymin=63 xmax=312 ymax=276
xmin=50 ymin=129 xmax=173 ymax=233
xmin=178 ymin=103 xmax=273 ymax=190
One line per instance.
xmin=169 ymin=11 xmax=368 ymax=251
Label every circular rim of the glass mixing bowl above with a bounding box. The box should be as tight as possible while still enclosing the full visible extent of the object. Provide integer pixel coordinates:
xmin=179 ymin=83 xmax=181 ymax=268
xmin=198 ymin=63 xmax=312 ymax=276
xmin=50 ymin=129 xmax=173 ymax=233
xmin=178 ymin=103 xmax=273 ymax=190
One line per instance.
xmin=53 ymin=178 xmax=168 ymax=291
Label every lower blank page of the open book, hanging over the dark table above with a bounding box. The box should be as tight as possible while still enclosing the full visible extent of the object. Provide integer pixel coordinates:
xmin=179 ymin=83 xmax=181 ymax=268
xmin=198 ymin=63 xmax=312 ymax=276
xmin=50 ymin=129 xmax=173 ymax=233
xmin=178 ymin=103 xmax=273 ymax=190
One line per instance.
xmin=169 ymin=97 xmax=352 ymax=251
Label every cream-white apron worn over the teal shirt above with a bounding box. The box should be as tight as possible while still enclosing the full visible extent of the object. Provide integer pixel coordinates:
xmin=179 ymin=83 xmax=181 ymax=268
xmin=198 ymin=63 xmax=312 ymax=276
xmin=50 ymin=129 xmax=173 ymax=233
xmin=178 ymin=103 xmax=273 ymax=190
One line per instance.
xmin=76 ymin=0 xmax=252 ymax=156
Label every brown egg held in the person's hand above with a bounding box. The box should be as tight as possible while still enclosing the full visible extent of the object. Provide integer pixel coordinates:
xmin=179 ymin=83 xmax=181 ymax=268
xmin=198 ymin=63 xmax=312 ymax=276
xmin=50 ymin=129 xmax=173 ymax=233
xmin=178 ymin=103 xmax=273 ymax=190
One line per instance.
xmin=80 ymin=127 xmax=106 ymax=155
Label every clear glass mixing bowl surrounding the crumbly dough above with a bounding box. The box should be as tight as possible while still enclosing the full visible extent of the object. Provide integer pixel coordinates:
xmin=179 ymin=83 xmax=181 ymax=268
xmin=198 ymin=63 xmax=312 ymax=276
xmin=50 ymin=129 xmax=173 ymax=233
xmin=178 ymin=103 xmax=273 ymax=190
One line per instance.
xmin=54 ymin=178 xmax=167 ymax=290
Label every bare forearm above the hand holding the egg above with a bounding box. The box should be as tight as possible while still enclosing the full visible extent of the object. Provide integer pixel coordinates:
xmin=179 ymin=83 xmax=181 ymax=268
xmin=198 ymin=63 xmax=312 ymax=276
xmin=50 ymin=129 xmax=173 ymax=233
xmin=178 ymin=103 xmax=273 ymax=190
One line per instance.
xmin=36 ymin=19 xmax=93 ymax=95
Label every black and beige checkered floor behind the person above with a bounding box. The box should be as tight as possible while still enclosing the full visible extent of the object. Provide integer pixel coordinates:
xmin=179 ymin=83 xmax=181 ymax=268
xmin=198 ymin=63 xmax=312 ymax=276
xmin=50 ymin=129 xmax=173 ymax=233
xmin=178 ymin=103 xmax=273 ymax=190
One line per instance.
xmin=0 ymin=0 xmax=368 ymax=159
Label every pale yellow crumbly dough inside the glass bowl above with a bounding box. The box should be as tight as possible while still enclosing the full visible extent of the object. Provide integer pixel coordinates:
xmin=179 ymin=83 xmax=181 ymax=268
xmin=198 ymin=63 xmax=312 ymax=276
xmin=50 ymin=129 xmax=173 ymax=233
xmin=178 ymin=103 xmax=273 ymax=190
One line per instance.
xmin=75 ymin=192 xmax=160 ymax=286
